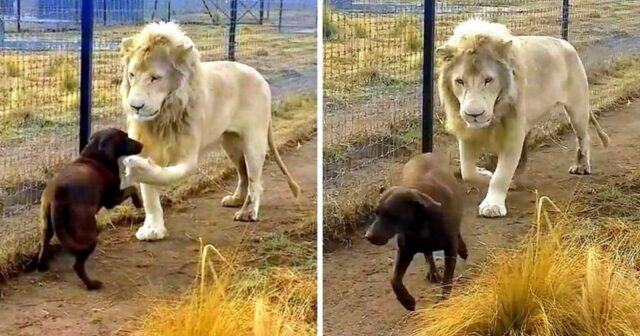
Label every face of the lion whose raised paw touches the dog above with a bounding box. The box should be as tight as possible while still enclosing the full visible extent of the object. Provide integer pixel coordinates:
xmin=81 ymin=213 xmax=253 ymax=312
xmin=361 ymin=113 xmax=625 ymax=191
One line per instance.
xmin=123 ymin=55 xmax=175 ymax=121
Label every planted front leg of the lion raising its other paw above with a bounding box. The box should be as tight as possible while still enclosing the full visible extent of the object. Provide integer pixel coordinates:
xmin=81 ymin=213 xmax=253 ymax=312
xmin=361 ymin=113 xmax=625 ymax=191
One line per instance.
xmin=136 ymin=183 xmax=167 ymax=240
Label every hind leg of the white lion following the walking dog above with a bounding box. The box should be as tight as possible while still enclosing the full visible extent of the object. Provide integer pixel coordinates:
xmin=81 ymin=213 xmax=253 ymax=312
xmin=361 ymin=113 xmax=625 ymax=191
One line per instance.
xmin=564 ymin=101 xmax=591 ymax=175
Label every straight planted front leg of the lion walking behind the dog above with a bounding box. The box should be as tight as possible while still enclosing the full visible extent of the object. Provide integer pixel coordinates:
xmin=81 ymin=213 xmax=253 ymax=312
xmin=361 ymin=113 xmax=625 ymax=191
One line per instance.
xmin=478 ymin=125 xmax=525 ymax=217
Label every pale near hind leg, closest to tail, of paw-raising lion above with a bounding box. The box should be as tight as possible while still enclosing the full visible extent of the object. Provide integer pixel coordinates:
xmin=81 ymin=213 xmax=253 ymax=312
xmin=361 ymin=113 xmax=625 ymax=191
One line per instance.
xmin=234 ymin=129 xmax=268 ymax=222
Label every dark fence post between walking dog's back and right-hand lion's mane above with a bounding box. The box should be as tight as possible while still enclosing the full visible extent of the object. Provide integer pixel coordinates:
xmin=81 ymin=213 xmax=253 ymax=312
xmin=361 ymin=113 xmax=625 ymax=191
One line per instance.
xmin=422 ymin=0 xmax=436 ymax=153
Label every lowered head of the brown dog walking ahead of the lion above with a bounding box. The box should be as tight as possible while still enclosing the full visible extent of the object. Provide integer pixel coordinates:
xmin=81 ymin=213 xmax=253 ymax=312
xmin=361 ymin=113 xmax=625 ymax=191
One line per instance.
xmin=365 ymin=187 xmax=441 ymax=245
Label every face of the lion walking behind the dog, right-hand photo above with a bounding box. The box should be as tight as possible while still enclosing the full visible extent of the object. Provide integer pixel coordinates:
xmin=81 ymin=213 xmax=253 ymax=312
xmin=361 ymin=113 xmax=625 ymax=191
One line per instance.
xmin=449 ymin=54 xmax=509 ymax=128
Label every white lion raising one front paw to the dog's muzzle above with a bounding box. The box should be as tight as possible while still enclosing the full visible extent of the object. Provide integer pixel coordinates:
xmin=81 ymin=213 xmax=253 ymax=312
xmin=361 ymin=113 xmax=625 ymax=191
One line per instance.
xmin=120 ymin=22 xmax=300 ymax=240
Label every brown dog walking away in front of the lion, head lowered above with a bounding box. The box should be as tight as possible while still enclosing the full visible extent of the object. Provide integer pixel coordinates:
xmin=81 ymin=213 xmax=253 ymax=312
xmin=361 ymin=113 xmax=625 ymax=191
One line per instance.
xmin=365 ymin=154 xmax=468 ymax=310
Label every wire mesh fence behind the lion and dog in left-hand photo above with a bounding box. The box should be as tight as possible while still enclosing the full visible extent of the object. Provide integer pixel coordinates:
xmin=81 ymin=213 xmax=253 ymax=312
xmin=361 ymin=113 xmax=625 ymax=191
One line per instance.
xmin=0 ymin=0 xmax=317 ymax=270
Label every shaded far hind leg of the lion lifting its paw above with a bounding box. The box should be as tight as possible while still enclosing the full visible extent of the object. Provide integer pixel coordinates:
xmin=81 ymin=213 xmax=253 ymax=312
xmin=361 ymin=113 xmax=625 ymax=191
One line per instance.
xmin=222 ymin=133 xmax=249 ymax=207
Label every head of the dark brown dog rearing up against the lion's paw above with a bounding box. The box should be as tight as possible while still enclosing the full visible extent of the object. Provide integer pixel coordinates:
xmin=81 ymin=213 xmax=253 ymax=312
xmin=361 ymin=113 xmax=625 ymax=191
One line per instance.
xmin=80 ymin=128 xmax=142 ymax=162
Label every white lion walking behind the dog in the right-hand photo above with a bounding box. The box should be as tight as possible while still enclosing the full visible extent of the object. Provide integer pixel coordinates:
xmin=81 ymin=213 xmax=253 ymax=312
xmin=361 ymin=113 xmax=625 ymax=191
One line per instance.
xmin=436 ymin=19 xmax=609 ymax=217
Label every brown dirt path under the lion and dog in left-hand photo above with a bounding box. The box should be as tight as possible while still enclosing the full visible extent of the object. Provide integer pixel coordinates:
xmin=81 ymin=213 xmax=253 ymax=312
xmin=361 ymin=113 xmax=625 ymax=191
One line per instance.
xmin=0 ymin=138 xmax=317 ymax=336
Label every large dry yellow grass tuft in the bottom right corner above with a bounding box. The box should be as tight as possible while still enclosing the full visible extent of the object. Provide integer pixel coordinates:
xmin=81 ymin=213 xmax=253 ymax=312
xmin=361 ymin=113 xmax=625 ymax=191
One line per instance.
xmin=415 ymin=197 xmax=640 ymax=336
